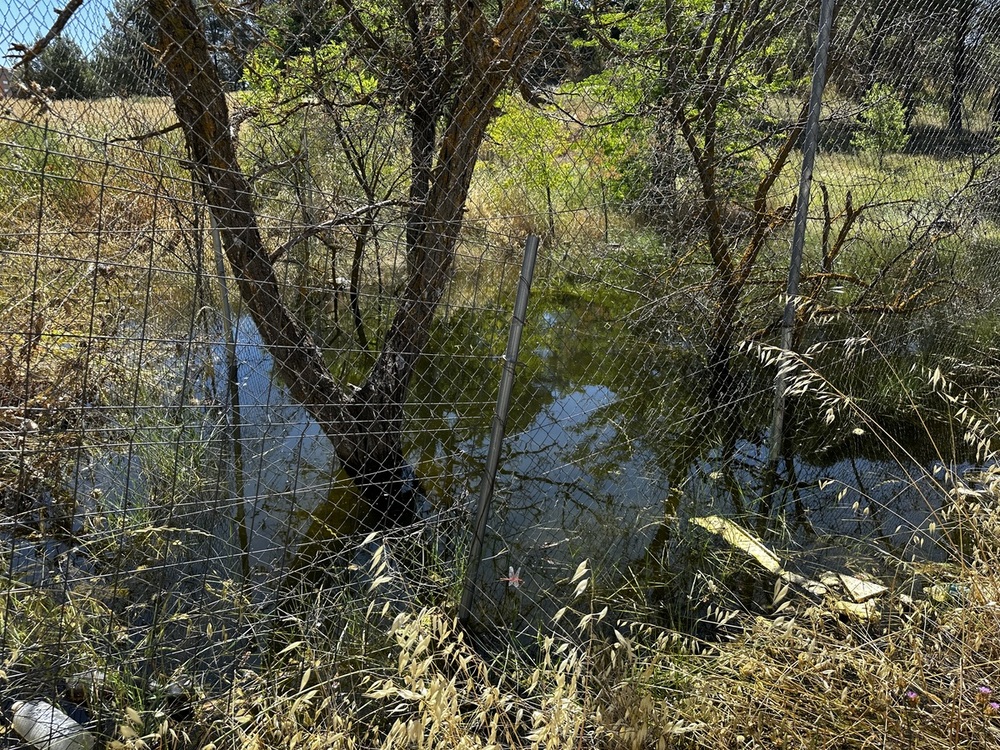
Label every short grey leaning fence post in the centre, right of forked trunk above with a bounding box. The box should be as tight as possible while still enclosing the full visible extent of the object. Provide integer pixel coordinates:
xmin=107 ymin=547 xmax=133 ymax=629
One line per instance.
xmin=458 ymin=234 xmax=538 ymax=626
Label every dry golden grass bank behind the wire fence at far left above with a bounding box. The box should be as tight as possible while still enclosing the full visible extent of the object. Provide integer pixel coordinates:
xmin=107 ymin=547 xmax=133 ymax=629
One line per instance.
xmin=0 ymin=100 xmax=213 ymax=533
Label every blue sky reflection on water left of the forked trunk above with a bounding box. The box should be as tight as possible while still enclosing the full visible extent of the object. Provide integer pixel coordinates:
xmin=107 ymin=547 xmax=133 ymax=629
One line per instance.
xmin=77 ymin=319 xmax=333 ymax=571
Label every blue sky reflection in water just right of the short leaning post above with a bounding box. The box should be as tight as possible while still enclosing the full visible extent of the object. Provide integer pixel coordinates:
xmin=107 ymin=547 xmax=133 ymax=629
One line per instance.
xmin=482 ymin=385 xmax=667 ymax=616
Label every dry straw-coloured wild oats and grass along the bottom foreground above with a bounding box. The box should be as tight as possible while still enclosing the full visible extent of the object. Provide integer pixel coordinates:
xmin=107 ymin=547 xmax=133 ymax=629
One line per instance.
xmin=113 ymin=524 xmax=1000 ymax=750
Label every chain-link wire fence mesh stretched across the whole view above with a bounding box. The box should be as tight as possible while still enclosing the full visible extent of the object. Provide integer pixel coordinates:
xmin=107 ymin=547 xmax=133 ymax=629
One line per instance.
xmin=0 ymin=0 xmax=1000 ymax=747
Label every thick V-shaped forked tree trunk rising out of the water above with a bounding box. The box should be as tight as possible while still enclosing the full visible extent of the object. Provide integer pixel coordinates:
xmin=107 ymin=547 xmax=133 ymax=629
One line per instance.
xmin=148 ymin=0 xmax=538 ymax=528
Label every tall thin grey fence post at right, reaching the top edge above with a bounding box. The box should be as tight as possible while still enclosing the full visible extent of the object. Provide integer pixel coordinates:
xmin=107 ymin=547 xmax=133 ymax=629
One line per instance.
xmin=762 ymin=0 xmax=834 ymax=508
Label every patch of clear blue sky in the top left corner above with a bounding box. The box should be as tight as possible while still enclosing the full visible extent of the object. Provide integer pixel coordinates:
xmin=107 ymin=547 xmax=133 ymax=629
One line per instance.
xmin=0 ymin=0 xmax=112 ymax=56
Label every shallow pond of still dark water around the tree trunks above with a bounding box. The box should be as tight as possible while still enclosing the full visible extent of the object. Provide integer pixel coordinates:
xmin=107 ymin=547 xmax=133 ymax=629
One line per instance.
xmin=95 ymin=274 xmax=972 ymax=621
